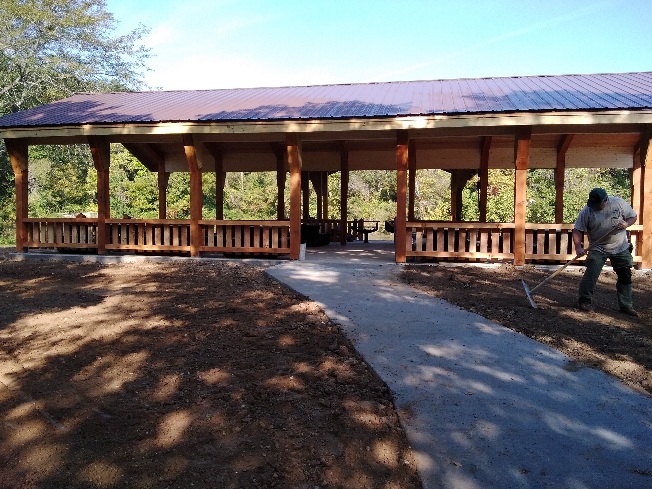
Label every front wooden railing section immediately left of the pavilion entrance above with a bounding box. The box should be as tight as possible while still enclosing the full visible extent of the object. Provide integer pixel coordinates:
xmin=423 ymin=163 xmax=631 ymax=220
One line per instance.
xmin=199 ymin=220 xmax=290 ymax=255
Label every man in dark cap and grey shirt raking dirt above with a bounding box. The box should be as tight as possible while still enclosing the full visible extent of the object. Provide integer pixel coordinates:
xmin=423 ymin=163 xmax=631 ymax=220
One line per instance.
xmin=573 ymin=188 xmax=638 ymax=317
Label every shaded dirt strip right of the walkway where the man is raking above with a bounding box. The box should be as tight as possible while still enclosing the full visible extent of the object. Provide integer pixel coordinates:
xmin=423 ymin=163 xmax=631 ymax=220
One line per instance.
xmin=402 ymin=265 xmax=652 ymax=395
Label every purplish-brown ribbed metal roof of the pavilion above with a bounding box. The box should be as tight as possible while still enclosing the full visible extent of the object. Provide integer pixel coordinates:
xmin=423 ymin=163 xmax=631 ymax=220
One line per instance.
xmin=0 ymin=72 xmax=652 ymax=128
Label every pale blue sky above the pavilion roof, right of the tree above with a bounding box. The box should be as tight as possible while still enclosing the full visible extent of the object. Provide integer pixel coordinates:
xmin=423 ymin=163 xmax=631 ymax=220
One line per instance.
xmin=106 ymin=0 xmax=652 ymax=90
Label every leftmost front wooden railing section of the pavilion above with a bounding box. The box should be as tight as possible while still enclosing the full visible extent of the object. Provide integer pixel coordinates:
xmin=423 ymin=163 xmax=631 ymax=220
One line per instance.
xmin=23 ymin=218 xmax=97 ymax=249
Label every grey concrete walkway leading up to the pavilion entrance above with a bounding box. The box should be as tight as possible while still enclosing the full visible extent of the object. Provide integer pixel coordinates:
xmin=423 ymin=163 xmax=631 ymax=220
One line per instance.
xmin=267 ymin=243 xmax=652 ymax=489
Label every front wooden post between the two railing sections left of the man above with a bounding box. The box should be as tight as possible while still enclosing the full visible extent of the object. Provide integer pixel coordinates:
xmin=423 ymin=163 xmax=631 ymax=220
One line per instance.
xmin=513 ymin=126 xmax=532 ymax=266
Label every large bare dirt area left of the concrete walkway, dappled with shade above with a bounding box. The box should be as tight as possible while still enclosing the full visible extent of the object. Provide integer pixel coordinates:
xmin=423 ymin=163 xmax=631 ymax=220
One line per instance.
xmin=0 ymin=254 xmax=421 ymax=489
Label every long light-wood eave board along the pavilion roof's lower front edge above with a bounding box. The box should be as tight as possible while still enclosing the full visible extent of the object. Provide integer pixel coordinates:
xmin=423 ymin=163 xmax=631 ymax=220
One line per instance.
xmin=0 ymin=109 xmax=652 ymax=144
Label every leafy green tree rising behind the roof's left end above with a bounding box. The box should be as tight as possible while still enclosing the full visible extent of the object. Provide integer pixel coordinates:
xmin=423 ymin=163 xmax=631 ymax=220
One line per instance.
xmin=0 ymin=0 xmax=149 ymax=239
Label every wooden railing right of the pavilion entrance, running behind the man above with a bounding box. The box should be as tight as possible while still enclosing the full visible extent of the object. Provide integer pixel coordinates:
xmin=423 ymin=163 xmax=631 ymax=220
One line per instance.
xmin=405 ymin=221 xmax=643 ymax=263
